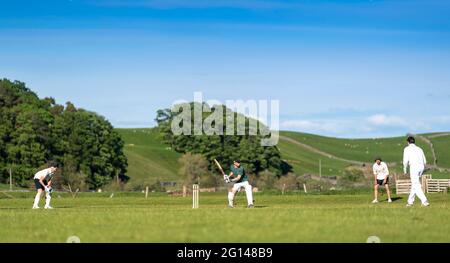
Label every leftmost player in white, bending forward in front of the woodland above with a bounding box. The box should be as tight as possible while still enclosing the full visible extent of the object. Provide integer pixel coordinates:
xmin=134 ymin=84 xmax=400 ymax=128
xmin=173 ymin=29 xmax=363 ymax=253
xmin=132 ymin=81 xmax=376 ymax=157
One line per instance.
xmin=33 ymin=164 xmax=58 ymax=209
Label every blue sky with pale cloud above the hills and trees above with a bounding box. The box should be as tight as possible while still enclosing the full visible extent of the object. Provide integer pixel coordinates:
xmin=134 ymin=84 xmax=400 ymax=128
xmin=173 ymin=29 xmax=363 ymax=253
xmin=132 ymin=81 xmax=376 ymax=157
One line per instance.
xmin=0 ymin=0 xmax=450 ymax=137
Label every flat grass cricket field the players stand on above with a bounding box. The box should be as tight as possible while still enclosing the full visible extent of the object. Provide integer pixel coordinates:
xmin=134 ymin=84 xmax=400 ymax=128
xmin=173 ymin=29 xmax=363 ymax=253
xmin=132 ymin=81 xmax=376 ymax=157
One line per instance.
xmin=0 ymin=193 xmax=450 ymax=243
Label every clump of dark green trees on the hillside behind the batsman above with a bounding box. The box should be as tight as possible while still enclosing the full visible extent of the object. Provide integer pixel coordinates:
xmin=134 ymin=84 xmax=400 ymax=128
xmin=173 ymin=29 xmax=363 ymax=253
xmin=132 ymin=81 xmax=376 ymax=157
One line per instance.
xmin=156 ymin=103 xmax=292 ymax=176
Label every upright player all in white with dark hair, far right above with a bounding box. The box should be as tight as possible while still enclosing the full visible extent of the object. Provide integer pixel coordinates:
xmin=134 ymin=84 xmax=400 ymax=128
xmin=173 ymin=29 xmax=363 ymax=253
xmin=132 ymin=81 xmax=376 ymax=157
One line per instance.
xmin=403 ymin=137 xmax=430 ymax=206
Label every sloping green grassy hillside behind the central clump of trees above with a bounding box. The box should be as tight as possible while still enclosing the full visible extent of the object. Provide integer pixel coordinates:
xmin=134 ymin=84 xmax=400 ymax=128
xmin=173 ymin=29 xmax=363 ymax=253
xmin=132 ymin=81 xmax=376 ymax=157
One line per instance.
xmin=117 ymin=129 xmax=450 ymax=185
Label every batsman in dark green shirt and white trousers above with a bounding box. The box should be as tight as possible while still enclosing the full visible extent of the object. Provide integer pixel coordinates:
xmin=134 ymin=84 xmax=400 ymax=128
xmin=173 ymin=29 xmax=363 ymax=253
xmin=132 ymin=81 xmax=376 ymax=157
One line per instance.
xmin=228 ymin=160 xmax=253 ymax=208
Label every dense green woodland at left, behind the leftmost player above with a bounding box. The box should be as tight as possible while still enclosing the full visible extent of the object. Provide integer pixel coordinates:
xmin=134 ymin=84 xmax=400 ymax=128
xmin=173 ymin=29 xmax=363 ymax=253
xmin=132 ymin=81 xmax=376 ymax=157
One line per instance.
xmin=0 ymin=79 xmax=127 ymax=189
